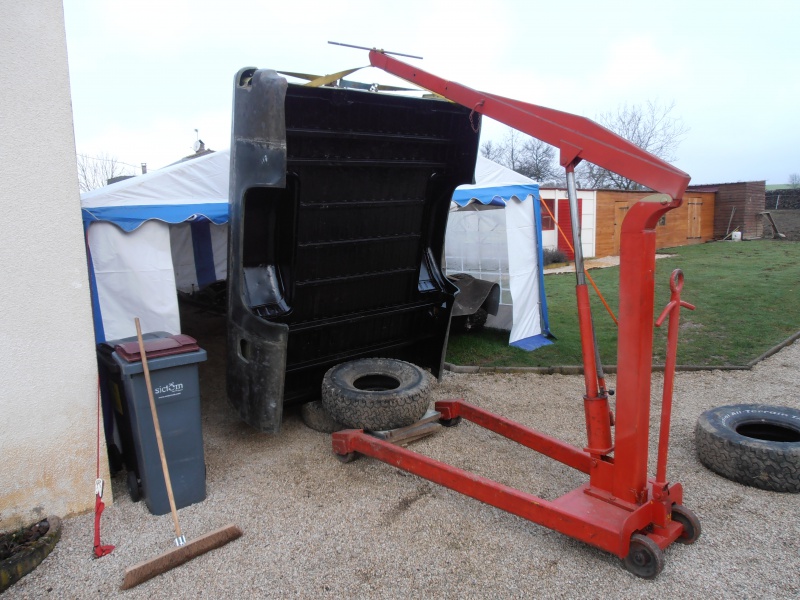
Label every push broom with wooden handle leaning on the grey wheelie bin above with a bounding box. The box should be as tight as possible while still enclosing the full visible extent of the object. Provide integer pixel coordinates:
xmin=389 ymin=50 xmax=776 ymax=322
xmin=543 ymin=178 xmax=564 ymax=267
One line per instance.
xmin=121 ymin=318 xmax=242 ymax=590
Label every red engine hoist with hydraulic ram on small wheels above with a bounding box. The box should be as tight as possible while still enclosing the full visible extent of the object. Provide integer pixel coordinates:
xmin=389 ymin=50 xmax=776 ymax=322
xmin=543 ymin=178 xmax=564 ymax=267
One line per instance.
xmin=333 ymin=50 xmax=700 ymax=578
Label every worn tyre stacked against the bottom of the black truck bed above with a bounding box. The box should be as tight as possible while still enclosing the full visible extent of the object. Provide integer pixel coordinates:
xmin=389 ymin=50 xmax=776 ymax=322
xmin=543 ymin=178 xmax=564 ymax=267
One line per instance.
xmin=322 ymin=358 xmax=431 ymax=431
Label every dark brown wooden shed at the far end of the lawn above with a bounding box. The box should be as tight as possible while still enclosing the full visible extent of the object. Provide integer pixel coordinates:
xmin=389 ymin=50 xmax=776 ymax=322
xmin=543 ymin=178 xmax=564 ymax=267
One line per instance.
xmin=714 ymin=181 xmax=766 ymax=240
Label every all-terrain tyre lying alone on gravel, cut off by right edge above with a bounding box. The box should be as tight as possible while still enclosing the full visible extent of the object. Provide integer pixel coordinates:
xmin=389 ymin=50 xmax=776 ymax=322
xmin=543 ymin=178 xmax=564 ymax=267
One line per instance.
xmin=695 ymin=404 xmax=800 ymax=493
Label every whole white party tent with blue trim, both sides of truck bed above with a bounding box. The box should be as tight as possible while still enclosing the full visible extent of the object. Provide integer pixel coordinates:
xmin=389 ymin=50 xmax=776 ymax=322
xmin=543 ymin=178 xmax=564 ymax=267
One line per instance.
xmin=81 ymin=150 xmax=549 ymax=349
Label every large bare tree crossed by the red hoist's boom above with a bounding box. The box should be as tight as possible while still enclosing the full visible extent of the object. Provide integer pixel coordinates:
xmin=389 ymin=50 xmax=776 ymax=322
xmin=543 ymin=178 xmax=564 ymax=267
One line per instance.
xmin=576 ymin=100 xmax=689 ymax=190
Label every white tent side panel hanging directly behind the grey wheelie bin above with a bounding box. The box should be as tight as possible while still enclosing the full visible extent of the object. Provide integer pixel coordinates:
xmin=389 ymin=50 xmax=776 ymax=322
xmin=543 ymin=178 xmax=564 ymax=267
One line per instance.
xmin=88 ymin=221 xmax=181 ymax=340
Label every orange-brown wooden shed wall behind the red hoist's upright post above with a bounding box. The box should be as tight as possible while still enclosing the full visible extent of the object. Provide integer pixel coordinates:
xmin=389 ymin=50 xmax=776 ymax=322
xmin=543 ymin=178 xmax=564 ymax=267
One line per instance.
xmin=596 ymin=190 xmax=715 ymax=256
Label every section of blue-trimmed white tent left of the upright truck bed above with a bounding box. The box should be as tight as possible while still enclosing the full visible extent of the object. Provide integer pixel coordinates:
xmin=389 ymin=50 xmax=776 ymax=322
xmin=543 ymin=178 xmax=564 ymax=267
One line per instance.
xmin=81 ymin=150 xmax=230 ymax=342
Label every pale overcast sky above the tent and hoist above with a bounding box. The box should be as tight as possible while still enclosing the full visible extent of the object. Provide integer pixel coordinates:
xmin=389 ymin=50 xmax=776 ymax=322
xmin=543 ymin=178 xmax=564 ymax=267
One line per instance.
xmin=64 ymin=0 xmax=800 ymax=184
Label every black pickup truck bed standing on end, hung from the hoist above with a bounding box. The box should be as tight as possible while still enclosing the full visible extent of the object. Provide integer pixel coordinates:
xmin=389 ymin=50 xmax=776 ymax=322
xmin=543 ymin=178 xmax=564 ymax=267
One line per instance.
xmin=227 ymin=68 xmax=480 ymax=431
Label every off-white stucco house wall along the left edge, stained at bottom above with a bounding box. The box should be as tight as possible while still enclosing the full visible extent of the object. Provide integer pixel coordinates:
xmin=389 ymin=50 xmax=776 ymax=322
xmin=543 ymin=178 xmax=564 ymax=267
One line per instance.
xmin=0 ymin=0 xmax=110 ymax=530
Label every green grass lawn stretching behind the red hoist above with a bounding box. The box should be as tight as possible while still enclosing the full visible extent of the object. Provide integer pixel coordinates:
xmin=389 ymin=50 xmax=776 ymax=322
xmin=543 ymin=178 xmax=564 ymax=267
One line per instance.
xmin=446 ymin=240 xmax=800 ymax=367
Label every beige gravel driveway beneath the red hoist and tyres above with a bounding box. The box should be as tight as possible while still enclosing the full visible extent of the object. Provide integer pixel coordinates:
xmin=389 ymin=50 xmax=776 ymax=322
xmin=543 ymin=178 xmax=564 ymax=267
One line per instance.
xmin=5 ymin=310 xmax=800 ymax=599
